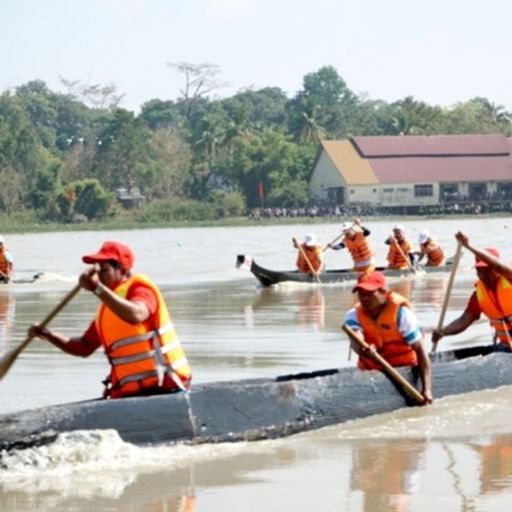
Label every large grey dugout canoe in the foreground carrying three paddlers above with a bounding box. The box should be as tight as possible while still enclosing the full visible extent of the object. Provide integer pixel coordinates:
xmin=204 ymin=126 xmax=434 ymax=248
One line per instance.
xmin=0 ymin=346 xmax=512 ymax=450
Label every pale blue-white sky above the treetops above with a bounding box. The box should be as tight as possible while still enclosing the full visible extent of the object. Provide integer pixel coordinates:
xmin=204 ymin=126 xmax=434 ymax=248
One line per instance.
xmin=0 ymin=0 xmax=512 ymax=111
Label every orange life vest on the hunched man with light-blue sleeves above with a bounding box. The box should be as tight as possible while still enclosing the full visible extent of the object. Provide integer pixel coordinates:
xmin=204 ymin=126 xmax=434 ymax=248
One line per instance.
xmin=356 ymin=292 xmax=418 ymax=370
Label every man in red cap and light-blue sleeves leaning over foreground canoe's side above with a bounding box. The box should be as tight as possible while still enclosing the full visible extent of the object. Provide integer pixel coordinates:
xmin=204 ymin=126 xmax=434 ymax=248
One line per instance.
xmin=345 ymin=271 xmax=432 ymax=403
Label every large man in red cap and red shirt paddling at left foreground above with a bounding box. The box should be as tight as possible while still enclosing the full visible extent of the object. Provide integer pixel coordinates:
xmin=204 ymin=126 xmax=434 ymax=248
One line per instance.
xmin=28 ymin=241 xmax=191 ymax=398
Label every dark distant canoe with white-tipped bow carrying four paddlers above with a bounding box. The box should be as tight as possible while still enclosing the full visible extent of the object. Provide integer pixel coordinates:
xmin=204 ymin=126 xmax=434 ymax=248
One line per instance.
xmin=236 ymin=254 xmax=452 ymax=288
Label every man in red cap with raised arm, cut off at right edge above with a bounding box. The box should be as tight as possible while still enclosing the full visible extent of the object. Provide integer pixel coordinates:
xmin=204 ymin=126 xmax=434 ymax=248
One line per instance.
xmin=432 ymin=231 xmax=512 ymax=352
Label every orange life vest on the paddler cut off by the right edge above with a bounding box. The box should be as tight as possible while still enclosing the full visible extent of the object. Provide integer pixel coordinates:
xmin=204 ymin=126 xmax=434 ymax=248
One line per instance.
xmin=475 ymin=276 xmax=512 ymax=347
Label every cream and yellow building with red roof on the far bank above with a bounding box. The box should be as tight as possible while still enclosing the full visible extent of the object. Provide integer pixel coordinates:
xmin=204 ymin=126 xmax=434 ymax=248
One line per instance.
xmin=310 ymin=134 xmax=512 ymax=211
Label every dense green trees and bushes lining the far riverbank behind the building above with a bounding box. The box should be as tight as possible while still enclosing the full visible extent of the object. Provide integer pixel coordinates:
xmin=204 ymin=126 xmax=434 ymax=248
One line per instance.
xmin=0 ymin=63 xmax=512 ymax=222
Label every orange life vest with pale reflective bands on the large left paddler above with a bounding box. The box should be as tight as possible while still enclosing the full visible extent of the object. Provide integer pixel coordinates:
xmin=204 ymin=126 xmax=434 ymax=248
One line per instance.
xmin=96 ymin=275 xmax=191 ymax=398
